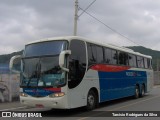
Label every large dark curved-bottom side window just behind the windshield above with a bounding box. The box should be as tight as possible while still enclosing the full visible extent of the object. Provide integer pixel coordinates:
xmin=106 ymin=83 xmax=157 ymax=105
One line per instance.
xmin=68 ymin=40 xmax=86 ymax=88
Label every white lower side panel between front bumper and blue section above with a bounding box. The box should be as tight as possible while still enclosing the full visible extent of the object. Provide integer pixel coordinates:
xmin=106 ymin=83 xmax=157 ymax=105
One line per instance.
xmin=68 ymin=69 xmax=100 ymax=108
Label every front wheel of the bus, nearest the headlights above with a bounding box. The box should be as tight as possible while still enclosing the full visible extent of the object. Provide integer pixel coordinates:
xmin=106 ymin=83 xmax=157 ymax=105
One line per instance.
xmin=86 ymin=90 xmax=97 ymax=110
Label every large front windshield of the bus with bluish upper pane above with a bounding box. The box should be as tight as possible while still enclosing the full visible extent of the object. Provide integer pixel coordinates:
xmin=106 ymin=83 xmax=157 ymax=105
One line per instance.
xmin=21 ymin=41 xmax=67 ymax=87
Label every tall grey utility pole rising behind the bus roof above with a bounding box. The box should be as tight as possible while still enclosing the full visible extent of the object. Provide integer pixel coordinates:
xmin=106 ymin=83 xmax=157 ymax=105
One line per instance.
xmin=73 ymin=0 xmax=78 ymax=36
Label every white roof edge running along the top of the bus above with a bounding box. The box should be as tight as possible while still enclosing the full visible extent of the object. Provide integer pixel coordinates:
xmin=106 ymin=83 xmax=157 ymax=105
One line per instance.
xmin=26 ymin=36 xmax=152 ymax=59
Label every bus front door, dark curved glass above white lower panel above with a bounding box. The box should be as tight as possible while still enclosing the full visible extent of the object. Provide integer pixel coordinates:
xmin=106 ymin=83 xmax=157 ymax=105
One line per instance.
xmin=68 ymin=40 xmax=86 ymax=108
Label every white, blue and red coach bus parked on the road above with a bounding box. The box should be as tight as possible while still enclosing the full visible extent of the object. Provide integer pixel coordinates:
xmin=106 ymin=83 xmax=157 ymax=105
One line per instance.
xmin=10 ymin=36 xmax=153 ymax=109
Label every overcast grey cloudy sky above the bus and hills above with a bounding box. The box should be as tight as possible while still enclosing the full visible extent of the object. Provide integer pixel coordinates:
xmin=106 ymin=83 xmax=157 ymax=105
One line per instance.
xmin=0 ymin=0 xmax=160 ymax=54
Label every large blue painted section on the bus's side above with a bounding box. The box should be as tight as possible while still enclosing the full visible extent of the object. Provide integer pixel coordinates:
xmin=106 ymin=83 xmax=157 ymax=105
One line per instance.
xmin=98 ymin=70 xmax=147 ymax=102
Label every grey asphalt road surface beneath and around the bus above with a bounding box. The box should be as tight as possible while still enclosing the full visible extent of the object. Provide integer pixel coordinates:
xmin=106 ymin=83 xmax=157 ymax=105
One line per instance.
xmin=0 ymin=86 xmax=160 ymax=120
